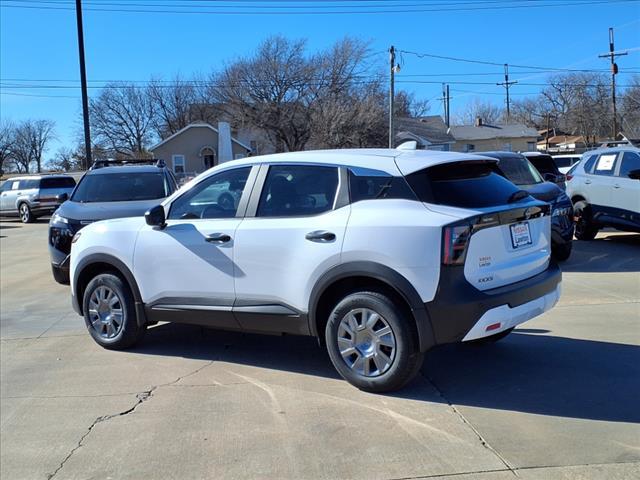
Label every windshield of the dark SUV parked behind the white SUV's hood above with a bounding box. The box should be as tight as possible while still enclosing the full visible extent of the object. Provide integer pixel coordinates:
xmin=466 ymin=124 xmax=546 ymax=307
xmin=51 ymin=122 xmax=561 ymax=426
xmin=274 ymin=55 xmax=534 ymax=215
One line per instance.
xmin=71 ymin=172 xmax=168 ymax=203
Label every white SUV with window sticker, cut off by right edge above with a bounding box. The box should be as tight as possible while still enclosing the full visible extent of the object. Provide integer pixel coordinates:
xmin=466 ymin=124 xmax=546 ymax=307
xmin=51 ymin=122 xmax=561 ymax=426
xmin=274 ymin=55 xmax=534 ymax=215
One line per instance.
xmin=567 ymin=147 xmax=640 ymax=240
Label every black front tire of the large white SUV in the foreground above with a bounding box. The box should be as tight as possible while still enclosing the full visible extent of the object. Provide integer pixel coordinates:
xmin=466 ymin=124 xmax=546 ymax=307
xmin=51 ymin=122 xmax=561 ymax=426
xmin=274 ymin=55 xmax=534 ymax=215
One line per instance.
xmin=82 ymin=273 xmax=146 ymax=350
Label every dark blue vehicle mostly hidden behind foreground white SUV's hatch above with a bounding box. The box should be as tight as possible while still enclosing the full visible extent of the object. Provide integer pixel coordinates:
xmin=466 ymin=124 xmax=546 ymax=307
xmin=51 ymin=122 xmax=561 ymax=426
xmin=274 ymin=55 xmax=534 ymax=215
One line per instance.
xmin=482 ymin=152 xmax=574 ymax=260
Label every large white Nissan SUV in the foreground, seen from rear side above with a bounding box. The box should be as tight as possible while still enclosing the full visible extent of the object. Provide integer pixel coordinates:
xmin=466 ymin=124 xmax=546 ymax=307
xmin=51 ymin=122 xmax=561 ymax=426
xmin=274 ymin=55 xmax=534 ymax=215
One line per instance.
xmin=71 ymin=150 xmax=561 ymax=392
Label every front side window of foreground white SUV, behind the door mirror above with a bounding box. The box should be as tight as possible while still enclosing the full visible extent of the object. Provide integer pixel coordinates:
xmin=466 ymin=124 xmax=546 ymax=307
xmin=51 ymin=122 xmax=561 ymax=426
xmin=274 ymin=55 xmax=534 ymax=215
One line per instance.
xmin=169 ymin=167 xmax=251 ymax=220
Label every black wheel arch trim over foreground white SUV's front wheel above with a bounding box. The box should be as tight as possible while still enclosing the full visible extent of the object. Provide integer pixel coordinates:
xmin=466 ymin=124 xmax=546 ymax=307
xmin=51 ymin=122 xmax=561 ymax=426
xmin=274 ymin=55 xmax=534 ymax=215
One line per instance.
xmin=73 ymin=253 xmax=146 ymax=326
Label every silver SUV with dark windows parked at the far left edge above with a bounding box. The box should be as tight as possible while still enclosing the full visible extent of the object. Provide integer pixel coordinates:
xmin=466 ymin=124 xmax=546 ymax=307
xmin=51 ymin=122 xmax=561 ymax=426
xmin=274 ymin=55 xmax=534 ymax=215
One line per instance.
xmin=0 ymin=175 xmax=76 ymax=223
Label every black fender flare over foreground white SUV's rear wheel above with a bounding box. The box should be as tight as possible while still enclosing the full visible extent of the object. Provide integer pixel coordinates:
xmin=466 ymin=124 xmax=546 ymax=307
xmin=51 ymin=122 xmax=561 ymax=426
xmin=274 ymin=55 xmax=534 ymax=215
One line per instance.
xmin=309 ymin=261 xmax=436 ymax=352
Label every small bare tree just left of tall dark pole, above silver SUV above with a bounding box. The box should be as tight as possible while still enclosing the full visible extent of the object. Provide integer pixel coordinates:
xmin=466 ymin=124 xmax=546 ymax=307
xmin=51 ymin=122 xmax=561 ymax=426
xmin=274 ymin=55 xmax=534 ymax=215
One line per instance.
xmin=11 ymin=120 xmax=55 ymax=173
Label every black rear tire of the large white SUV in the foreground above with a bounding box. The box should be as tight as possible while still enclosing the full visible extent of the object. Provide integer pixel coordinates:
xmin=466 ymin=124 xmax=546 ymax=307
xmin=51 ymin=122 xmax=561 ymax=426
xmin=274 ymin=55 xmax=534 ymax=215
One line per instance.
xmin=325 ymin=292 xmax=424 ymax=393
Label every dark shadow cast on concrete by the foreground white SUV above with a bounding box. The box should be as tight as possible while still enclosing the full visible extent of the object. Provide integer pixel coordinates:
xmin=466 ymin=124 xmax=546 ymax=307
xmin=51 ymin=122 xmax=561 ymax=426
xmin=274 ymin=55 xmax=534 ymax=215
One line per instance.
xmin=135 ymin=324 xmax=640 ymax=423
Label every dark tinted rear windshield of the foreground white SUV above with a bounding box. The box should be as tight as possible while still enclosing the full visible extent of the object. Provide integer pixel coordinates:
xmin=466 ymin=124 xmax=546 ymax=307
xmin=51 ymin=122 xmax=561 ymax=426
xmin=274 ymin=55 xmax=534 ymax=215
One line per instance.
xmin=407 ymin=162 xmax=528 ymax=208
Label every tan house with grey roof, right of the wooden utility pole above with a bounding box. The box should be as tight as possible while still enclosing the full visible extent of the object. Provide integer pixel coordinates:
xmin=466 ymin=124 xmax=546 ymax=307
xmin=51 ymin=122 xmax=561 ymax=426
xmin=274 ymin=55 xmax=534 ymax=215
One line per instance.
xmin=449 ymin=118 xmax=538 ymax=153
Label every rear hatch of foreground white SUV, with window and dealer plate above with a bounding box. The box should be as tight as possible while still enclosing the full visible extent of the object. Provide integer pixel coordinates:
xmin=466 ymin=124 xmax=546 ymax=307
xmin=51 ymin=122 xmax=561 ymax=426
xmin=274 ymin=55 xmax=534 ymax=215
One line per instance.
xmin=406 ymin=160 xmax=551 ymax=290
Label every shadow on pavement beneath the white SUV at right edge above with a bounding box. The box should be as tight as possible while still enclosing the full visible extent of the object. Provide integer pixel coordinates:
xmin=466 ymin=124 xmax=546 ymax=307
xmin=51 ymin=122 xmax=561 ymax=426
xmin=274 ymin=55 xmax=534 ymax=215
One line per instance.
xmin=560 ymin=232 xmax=640 ymax=272
